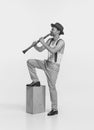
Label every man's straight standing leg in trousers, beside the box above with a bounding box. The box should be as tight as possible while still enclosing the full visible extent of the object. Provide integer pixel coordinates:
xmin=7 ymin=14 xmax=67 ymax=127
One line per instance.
xmin=46 ymin=63 xmax=59 ymax=110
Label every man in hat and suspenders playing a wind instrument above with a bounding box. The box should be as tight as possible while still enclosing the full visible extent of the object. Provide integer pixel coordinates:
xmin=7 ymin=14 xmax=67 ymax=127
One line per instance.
xmin=27 ymin=23 xmax=65 ymax=116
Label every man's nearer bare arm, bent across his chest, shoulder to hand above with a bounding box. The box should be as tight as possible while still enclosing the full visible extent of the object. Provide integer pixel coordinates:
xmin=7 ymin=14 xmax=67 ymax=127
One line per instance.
xmin=40 ymin=38 xmax=65 ymax=53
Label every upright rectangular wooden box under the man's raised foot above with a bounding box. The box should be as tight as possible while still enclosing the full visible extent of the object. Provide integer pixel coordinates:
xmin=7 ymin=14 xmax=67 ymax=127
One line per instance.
xmin=26 ymin=85 xmax=46 ymax=114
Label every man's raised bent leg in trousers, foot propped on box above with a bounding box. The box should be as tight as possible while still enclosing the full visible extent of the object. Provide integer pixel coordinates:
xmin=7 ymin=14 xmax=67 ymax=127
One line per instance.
xmin=27 ymin=59 xmax=45 ymax=82
